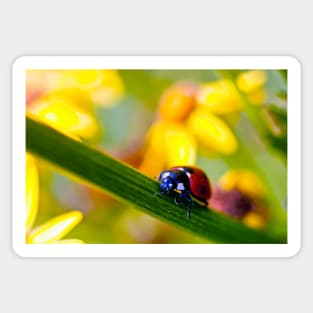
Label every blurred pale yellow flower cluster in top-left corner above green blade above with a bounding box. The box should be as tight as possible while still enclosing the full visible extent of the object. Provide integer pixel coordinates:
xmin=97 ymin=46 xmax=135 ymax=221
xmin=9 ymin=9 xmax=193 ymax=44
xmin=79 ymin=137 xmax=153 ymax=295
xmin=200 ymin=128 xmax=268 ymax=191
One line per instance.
xmin=26 ymin=70 xmax=124 ymax=139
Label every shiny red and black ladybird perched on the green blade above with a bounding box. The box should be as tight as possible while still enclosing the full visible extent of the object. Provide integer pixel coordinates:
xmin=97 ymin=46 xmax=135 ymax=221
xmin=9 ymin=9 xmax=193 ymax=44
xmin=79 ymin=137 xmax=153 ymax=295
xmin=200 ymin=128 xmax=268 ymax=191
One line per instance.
xmin=159 ymin=166 xmax=212 ymax=219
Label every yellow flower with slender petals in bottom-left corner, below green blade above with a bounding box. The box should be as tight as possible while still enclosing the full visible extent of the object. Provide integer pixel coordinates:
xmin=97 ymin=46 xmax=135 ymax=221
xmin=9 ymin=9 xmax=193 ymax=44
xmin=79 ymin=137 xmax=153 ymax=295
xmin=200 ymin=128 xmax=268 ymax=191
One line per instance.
xmin=26 ymin=154 xmax=83 ymax=244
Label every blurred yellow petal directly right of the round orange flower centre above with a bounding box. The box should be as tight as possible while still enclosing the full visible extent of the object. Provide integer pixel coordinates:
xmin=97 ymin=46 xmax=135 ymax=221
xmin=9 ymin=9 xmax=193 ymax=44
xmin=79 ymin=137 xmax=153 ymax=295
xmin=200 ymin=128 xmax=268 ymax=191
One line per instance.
xmin=197 ymin=79 xmax=243 ymax=114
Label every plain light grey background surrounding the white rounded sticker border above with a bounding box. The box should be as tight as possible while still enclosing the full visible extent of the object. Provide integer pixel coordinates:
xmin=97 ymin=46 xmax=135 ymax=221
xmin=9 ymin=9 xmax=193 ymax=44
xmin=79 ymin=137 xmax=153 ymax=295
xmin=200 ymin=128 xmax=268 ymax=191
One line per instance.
xmin=0 ymin=0 xmax=313 ymax=313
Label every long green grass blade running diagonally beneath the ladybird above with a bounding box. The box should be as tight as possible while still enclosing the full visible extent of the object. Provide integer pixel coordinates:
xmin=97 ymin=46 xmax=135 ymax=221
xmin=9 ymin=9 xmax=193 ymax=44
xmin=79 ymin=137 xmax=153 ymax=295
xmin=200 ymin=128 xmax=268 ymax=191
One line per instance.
xmin=26 ymin=117 xmax=286 ymax=243
